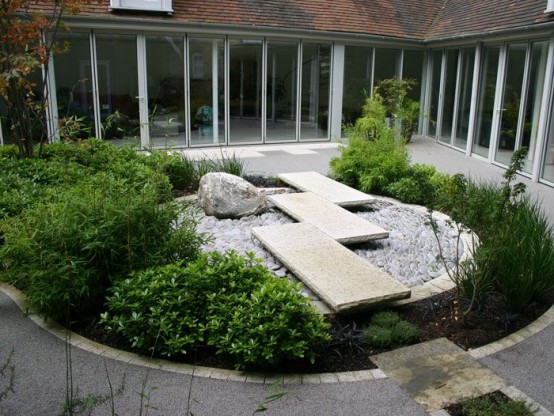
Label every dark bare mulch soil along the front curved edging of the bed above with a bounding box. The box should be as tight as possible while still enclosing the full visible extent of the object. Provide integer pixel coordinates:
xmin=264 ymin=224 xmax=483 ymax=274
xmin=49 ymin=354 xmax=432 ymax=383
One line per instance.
xmin=71 ymin=291 xmax=554 ymax=373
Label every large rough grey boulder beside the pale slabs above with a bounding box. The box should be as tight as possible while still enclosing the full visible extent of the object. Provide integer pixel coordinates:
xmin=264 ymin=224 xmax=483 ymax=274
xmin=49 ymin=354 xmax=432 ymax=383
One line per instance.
xmin=198 ymin=172 xmax=267 ymax=218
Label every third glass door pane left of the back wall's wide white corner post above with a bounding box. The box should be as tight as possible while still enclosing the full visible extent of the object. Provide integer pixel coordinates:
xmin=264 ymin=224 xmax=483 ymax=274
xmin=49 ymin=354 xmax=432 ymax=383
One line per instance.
xmin=229 ymin=39 xmax=263 ymax=144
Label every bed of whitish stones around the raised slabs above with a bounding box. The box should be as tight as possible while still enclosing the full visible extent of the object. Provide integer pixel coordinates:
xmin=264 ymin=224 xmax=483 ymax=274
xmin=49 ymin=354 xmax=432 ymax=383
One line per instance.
xmin=197 ymin=200 xmax=463 ymax=297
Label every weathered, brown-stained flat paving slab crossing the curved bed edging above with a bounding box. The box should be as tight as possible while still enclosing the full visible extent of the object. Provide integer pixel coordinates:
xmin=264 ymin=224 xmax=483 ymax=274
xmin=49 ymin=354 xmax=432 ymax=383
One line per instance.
xmin=371 ymin=338 xmax=506 ymax=412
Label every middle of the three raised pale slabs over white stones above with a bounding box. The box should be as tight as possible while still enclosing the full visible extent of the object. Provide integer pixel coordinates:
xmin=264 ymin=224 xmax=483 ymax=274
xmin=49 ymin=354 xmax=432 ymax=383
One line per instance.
xmin=268 ymin=192 xmax=389 ymax=244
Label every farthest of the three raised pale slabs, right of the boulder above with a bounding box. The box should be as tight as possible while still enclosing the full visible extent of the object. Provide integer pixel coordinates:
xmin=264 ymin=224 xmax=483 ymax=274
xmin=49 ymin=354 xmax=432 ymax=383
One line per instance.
xmin=278 ymin=172 xmax=375 ymax=207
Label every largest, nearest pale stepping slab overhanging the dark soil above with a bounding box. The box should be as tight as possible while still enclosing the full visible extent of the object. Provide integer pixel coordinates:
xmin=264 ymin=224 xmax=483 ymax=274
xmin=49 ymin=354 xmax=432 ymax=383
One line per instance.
xmin=252 ymin=222 xmax=410 ymax=312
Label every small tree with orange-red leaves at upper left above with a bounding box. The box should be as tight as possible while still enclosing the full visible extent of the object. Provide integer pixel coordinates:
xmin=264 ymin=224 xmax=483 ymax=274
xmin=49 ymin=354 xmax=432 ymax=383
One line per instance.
xmin=0 ymin=0 xmax=98 ymax=157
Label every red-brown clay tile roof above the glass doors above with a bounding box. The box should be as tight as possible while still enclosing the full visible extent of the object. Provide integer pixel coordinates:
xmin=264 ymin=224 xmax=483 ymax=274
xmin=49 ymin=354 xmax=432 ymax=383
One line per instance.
xmin=24 ymin=0 xmax=554 ymax=40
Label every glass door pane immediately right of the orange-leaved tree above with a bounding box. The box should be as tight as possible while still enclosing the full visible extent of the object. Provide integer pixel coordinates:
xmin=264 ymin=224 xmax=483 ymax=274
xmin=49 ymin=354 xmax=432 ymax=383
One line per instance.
xmin=54 ymin=33 xmax=95 ymax=140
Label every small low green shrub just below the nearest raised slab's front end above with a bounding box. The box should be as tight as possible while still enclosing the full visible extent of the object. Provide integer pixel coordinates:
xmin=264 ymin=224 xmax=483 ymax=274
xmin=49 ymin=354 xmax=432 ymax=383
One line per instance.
xmin=363 ymin=311 xmax=421 ymax=348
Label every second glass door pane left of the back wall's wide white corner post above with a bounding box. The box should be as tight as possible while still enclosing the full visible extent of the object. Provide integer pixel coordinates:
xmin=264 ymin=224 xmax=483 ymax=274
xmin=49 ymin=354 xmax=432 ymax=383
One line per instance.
xmin=266 ymin=41 xmax=298 ymax=142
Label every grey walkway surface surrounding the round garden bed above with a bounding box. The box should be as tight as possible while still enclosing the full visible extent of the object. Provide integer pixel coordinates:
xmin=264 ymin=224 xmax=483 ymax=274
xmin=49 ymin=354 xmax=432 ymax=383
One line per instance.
xmin=0 ymin=138 xmax=554 ymax=416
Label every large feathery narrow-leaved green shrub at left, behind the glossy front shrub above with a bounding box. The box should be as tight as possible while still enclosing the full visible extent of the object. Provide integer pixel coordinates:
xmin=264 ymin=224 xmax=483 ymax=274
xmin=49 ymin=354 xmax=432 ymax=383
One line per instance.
xmin=0 ymin=173 xmax=203 ymax=319
